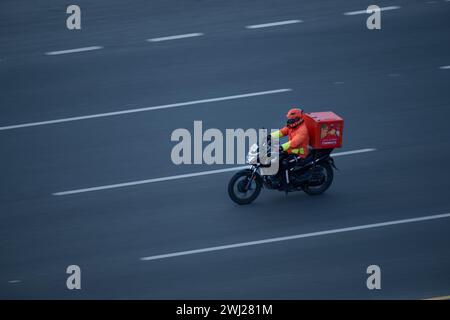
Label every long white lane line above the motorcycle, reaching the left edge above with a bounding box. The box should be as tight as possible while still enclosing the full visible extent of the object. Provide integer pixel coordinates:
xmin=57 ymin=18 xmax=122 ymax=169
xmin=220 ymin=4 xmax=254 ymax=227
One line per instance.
xmin=0 ymin=89 xmax=292 ymax=131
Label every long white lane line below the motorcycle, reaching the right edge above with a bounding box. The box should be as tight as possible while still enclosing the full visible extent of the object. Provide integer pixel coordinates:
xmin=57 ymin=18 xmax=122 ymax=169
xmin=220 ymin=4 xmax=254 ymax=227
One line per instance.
xmin=140 ymin=213 xmax=450 ymax=261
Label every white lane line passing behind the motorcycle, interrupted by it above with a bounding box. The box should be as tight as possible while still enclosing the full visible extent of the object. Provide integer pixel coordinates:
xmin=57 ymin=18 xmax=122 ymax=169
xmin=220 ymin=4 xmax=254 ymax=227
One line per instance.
xmin=52 ymin=148 xmax=376 ymax=196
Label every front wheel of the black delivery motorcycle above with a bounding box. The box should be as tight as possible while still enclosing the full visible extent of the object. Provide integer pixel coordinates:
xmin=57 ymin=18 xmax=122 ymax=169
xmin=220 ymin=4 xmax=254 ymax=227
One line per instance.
xmin=228 ymin=169 xmax=262 ymax=205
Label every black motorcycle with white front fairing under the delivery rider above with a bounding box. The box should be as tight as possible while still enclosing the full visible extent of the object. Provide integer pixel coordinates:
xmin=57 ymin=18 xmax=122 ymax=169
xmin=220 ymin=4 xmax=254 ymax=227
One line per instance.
xmin=228 ymin=139 xmax=337 ymax=205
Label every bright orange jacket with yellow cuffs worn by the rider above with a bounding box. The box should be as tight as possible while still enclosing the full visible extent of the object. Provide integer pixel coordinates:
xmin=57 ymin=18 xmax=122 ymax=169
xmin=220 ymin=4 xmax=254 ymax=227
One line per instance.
xmin=272 ymin=122 xmax=309 ymax=158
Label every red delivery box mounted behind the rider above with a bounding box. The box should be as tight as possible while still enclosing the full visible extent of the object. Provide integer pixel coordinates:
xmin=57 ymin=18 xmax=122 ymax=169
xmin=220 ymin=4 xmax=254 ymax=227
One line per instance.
xmin=304 ymin=111 xmax=344 ymax=149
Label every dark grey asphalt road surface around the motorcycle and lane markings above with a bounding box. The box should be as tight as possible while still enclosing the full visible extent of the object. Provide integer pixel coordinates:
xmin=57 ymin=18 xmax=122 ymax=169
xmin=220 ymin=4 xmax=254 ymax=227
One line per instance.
xmin=0 ymin=0 xmax=450 ymax=299
